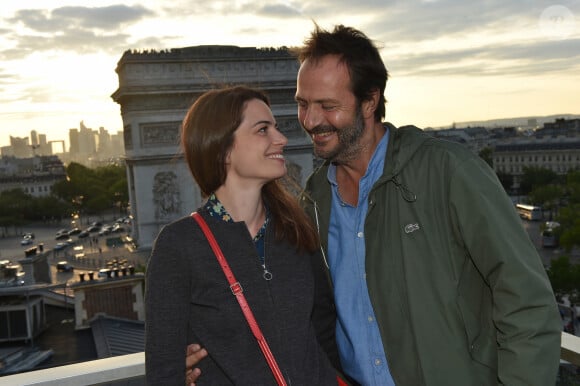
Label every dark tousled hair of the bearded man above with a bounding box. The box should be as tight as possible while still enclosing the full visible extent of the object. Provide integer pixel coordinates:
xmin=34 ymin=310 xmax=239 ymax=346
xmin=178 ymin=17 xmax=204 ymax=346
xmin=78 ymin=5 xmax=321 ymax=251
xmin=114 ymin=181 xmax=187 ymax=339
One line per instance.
xmin=292 ymin=24 xmax=389 ymax=122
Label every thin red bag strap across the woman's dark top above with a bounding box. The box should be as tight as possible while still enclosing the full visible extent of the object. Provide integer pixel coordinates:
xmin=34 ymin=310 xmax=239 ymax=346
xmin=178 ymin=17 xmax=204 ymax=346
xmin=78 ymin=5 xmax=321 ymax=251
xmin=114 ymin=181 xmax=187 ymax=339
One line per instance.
xmin=191 ymin=212 xmax=286 ymax=386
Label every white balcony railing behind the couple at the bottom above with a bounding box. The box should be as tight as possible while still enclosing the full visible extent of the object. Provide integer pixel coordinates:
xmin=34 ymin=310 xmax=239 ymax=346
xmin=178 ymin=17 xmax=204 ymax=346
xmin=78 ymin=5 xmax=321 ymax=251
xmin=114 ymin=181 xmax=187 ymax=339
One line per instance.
xmin=0 ymin=332 xmax=580 ymax=386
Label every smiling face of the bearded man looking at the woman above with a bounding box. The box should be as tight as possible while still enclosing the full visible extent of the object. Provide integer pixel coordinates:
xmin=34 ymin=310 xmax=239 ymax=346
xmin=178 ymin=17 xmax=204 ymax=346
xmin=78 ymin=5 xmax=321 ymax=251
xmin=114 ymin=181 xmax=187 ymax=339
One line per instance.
xmin=296 ymin=55 xmax=364 ymax=162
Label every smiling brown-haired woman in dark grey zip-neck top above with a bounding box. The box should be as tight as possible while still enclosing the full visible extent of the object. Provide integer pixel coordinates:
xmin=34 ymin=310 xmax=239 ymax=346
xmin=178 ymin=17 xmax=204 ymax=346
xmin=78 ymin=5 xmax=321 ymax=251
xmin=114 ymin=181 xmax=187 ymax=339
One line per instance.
xmin=145 ymin=87 xmax=336 ymax=386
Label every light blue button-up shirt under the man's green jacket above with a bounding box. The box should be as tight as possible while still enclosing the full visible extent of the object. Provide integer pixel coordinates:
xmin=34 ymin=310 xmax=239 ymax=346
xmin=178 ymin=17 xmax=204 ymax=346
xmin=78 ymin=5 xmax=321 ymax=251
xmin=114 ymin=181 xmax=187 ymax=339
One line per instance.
xmin=327 ymin=130 xmax=395 ymax=386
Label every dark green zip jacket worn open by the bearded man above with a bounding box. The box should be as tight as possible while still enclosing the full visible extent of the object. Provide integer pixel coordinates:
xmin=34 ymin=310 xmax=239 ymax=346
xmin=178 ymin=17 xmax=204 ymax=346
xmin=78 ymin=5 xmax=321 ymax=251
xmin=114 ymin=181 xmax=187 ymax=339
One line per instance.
xmin=302 ymin=124 xmax=562 ymax=386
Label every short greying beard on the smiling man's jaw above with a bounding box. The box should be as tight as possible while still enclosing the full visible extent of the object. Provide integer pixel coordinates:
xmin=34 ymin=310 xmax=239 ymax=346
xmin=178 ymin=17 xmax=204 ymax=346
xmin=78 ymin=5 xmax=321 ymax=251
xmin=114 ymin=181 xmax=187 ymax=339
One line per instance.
xmin=312 ymin=106 xmax=364 ymax=163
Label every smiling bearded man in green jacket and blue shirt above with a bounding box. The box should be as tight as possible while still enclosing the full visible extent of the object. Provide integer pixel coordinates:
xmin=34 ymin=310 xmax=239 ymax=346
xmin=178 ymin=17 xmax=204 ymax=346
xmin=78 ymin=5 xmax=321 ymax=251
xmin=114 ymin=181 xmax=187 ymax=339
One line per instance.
xmin=188 ymin=26 xmax=561 ymax=386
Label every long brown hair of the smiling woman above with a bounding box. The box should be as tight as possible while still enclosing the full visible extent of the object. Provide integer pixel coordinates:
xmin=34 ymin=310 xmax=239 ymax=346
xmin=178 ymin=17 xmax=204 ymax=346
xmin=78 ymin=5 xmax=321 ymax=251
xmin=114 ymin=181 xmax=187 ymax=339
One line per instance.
xmin=181 ymin=86 xmax=319 ymax=252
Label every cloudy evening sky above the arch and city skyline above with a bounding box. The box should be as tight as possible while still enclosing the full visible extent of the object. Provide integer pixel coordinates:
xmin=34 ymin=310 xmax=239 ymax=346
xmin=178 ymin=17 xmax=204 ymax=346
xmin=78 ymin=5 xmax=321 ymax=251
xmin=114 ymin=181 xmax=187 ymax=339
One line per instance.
xmin=0 ymin=0 xmax=580 ymax=146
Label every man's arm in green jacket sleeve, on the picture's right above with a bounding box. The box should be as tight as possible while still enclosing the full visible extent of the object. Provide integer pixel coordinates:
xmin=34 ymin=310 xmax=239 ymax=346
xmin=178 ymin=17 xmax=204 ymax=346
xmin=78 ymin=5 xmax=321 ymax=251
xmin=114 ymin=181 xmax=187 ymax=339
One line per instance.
xmin=450 ymin=158 xmax=561 ymax=385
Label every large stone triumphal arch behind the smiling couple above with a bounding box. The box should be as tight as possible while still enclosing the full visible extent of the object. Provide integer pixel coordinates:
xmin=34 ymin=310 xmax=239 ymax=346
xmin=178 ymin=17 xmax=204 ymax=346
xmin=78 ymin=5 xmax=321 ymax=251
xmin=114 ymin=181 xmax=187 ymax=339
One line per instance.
xmin=112 ymin=46 xmax=313 ymax=248
